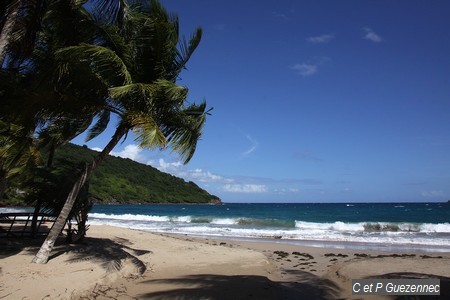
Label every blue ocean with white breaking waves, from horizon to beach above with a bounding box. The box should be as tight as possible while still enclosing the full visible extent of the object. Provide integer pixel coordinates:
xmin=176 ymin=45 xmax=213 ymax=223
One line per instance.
xmin=0 ymin=203 xmax=450 ymax=252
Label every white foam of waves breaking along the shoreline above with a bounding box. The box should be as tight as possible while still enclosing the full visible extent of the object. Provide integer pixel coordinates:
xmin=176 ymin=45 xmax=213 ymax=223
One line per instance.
xmin=89 ymin=213 xmax=450 ymax=250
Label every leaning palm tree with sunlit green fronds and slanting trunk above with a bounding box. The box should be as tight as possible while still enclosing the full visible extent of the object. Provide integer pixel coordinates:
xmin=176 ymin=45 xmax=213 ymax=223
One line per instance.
xmin=33 ymin=0 xmax=208 ymax=263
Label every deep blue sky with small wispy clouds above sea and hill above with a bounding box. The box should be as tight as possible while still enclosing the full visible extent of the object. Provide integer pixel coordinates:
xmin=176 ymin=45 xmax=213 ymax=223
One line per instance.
xmin=75 ymin=0 xmax=450 ymax=202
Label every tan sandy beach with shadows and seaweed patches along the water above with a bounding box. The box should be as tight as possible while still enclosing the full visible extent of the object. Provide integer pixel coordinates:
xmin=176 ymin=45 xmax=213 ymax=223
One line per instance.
xmin=0 ymin=226 xmax=450 ymax=299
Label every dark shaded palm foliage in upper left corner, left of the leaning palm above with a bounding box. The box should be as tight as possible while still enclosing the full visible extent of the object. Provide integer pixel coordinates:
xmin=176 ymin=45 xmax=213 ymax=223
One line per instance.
xmin=0 ymin=0 xmax=107 ymax=199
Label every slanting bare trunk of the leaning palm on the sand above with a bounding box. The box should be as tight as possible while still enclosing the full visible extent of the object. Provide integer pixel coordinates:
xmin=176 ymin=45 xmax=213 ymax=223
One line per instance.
xmin=33 ymin=123 xmax=128 ymax=264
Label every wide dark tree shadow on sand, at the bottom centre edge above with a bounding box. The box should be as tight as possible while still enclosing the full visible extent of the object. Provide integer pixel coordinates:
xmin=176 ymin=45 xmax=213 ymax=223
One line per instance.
xmin=140 ymin=272 xmax=340 ymax=300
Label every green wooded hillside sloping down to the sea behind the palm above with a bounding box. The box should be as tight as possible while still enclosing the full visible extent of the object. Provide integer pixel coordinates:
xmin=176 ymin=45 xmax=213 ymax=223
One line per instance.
xmin=50 ymin=144 xmax=219 ymax=203
